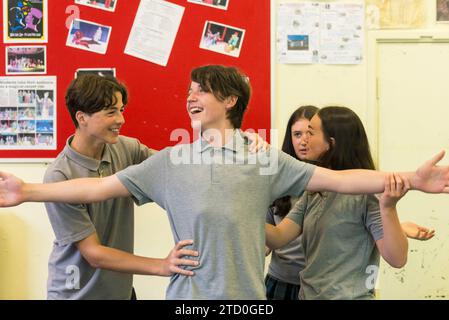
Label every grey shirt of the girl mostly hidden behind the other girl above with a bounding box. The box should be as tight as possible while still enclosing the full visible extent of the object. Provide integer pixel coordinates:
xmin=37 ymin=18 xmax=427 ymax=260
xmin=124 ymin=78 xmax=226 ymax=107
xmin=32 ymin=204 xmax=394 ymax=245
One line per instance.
xmin=266 ymin=197 xmax=306 ymax=285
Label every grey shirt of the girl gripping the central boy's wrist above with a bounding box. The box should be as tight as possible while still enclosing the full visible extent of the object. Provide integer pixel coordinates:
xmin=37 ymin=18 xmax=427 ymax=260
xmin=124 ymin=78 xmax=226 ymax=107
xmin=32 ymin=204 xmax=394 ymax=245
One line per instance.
xmin=286 ymin=192 xmax=383 ymax=300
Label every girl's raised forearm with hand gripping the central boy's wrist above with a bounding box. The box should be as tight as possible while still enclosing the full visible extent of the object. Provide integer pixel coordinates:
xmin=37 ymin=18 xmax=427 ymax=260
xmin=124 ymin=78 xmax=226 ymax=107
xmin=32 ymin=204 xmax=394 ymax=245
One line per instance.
xmin=376 ymin=174 xmax=408 ymax=268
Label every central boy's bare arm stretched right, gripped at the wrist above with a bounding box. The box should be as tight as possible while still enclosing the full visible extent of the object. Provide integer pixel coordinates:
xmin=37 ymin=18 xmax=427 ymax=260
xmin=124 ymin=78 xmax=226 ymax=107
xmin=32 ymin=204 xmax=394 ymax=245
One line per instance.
xmin=306 ymin=151 xmax=449 ymax=194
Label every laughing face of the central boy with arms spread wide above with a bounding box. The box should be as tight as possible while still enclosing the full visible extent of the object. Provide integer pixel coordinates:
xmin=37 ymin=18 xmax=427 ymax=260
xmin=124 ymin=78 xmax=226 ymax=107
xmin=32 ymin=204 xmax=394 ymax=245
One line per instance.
xmin=187 ymin=81 xmax=232 ymax=131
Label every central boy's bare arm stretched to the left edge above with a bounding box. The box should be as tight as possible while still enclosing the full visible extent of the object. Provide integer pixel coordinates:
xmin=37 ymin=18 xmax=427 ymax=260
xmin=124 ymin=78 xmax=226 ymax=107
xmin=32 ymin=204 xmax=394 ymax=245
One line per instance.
xmin=0 ymin=172 xmax=130 ymax=207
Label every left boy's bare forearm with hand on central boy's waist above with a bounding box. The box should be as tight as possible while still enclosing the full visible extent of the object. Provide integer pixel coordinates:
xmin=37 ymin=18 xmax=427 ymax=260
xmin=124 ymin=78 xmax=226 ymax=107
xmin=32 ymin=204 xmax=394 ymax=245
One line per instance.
xmin=76 ymin=233 xmax=198 ymax=277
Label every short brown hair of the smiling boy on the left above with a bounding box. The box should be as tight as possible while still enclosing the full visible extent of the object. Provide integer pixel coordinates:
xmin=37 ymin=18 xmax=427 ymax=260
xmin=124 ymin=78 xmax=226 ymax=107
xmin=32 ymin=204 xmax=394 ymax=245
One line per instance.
xmin=65 ymin=74 xmax=128 ymax=128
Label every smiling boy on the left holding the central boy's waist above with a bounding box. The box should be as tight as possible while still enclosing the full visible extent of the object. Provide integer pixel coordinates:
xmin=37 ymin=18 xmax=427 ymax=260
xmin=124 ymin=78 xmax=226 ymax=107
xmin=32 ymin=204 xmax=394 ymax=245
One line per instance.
xmin=44 ymin=75 xmax=196 ymax=300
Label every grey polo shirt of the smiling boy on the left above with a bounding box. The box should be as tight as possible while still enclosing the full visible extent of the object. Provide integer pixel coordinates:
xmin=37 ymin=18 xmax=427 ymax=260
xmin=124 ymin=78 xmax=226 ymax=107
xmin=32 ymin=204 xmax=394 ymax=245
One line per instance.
xmin=44 ymin=136 xmax=154 ymax=300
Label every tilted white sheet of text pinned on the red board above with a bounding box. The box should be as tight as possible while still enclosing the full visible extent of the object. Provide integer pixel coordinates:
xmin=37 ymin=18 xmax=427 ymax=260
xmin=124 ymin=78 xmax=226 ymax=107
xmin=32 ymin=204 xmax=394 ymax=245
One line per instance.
xmin=125 ymin=0 xmax=184 ymax=66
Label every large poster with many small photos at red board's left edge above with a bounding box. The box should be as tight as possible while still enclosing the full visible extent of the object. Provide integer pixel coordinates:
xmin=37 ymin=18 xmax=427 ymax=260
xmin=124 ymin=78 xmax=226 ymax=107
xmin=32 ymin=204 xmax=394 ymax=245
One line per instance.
xmin=0 ymin=76 xmax=57 ymax=150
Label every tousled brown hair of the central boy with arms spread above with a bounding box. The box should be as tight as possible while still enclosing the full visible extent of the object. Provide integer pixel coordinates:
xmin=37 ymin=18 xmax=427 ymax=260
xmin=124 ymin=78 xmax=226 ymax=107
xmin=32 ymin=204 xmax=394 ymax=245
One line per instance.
xmin=190 ymin=65 xmax=251 ymax=128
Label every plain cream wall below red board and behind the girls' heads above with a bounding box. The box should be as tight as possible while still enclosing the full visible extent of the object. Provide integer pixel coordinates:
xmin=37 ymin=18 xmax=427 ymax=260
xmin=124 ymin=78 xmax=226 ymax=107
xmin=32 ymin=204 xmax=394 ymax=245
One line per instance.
xmin=0 ymin=0 xmax=449 ymax=299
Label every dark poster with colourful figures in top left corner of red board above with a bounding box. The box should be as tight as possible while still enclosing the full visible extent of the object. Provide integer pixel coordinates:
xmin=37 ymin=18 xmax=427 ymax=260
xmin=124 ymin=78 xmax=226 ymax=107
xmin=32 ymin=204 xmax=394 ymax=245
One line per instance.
xmin=3 ymin=0 xmax=48 ymax=43
